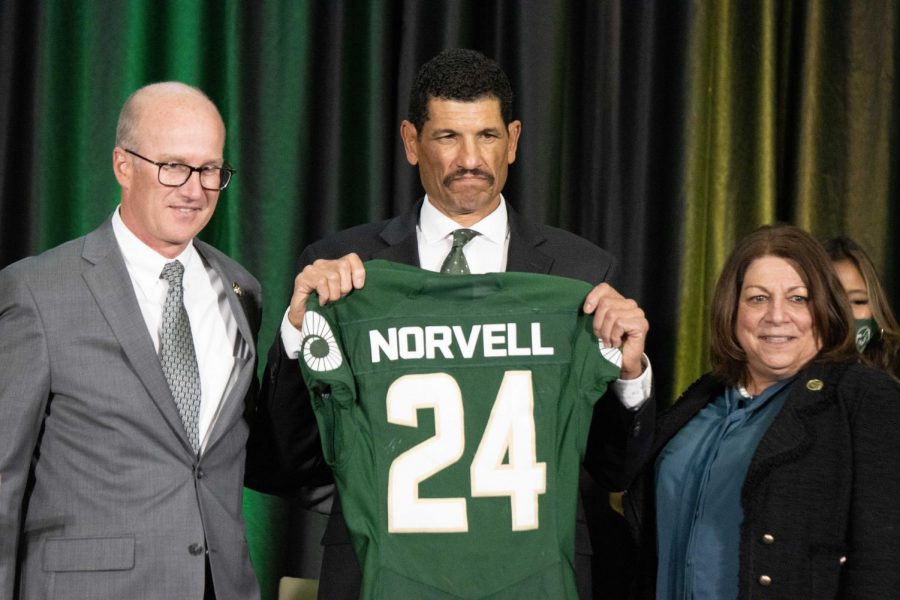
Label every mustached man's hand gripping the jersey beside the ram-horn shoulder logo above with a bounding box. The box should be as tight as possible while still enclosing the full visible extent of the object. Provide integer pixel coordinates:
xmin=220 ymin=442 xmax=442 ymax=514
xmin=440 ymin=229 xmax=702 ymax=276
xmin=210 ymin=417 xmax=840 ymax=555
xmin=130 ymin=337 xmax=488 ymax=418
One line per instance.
xmin=288 ymin=252 xmax=366 ymax=330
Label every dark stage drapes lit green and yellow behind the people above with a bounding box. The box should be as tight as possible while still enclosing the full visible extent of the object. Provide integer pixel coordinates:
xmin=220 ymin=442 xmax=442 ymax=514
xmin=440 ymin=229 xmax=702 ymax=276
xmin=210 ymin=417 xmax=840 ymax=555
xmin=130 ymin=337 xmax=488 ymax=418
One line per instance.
xmin=0 ymin=0 xmax=900 ymax=594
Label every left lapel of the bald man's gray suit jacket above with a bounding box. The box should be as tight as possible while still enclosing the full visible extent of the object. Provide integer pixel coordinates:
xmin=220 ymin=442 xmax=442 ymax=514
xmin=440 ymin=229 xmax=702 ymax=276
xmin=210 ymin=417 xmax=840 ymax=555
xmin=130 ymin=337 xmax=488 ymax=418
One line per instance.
xmin=82 ymin=221 xmax=191 ymax=450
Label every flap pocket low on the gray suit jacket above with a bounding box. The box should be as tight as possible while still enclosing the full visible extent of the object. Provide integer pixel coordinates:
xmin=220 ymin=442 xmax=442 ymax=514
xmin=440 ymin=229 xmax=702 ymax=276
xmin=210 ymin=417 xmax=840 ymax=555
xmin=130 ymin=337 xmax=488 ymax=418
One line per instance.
xmin=42 ymin=536 xmax=134 ymax=572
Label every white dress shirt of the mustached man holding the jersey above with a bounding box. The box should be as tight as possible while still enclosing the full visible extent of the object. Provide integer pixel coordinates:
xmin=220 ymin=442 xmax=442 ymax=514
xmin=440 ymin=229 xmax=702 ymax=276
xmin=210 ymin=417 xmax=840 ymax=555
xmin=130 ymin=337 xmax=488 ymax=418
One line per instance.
xmin=281 ymin=195 xmax=653 ymax=410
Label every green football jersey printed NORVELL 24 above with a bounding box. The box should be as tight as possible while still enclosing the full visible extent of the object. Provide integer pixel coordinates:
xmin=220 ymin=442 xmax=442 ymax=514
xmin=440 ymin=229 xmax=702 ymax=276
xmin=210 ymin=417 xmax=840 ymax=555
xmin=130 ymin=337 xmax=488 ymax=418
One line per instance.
xmin=300 ymin=260 xmax=619 ymax=599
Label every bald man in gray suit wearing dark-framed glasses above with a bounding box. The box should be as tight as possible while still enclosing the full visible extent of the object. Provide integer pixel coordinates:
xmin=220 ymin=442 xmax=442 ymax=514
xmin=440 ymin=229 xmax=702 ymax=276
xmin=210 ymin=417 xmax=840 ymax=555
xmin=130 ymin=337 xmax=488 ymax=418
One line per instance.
xmin=0 ymin=82 xmax=260 ymax=600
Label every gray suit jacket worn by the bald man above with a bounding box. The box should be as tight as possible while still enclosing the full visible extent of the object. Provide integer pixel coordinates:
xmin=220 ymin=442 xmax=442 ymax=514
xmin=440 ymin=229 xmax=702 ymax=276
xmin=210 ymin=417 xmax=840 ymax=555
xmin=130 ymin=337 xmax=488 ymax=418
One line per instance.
xmin=0 ymin=221 xmax=260 ymax=600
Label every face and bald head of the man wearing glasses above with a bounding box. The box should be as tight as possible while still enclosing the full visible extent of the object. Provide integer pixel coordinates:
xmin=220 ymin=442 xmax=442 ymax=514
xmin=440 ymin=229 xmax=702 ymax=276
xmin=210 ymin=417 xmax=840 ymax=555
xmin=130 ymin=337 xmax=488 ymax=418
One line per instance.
xmin=113 ymin=85 xmax=225 ymax=258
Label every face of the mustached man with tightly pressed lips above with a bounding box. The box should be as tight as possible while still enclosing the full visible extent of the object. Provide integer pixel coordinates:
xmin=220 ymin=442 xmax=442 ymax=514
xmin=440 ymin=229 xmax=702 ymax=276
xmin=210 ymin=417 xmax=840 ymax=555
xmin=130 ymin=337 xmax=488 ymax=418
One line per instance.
xmin=400 ymin=97 xmax=522 ymax=227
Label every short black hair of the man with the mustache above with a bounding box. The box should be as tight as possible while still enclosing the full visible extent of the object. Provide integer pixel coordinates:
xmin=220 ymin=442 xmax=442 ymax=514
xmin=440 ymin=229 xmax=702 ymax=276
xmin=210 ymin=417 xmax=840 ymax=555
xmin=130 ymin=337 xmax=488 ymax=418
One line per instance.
xmin=406 ymin=48 xmax=513 ymax=134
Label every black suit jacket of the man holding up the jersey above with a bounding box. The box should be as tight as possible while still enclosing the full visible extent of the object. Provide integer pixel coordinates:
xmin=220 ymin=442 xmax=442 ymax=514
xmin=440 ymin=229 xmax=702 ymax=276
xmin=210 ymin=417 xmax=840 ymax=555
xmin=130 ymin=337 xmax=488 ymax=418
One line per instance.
xmin=246 ymin=202 xmax=655 ymax=600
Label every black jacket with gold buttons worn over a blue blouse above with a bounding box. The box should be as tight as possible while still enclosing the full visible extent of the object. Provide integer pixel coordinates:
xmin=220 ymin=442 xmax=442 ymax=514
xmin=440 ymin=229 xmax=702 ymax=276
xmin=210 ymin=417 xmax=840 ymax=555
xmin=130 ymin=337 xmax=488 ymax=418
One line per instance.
xmin=625 ymin=363 xmax=900 ymax=600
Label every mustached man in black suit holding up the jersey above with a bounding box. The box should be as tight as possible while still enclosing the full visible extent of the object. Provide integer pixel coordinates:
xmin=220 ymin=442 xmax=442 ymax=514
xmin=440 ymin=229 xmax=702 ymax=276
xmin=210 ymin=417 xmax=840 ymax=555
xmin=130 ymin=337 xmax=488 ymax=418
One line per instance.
xmin=247 ymin=50 xmax=653 ymax=599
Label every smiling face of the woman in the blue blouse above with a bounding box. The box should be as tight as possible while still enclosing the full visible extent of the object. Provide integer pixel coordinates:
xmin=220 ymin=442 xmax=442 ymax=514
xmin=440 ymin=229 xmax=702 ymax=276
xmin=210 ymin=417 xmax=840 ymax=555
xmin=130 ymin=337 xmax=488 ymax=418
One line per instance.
xmin=735 ymin=256 xmax=821 ymax=394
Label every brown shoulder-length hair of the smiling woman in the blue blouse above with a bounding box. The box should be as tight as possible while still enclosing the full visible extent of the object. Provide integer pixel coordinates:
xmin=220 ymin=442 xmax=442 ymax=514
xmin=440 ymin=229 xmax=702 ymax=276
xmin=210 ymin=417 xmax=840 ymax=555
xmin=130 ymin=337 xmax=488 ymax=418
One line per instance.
xmin=710 ymin=223 xmax=857 ymax=385
